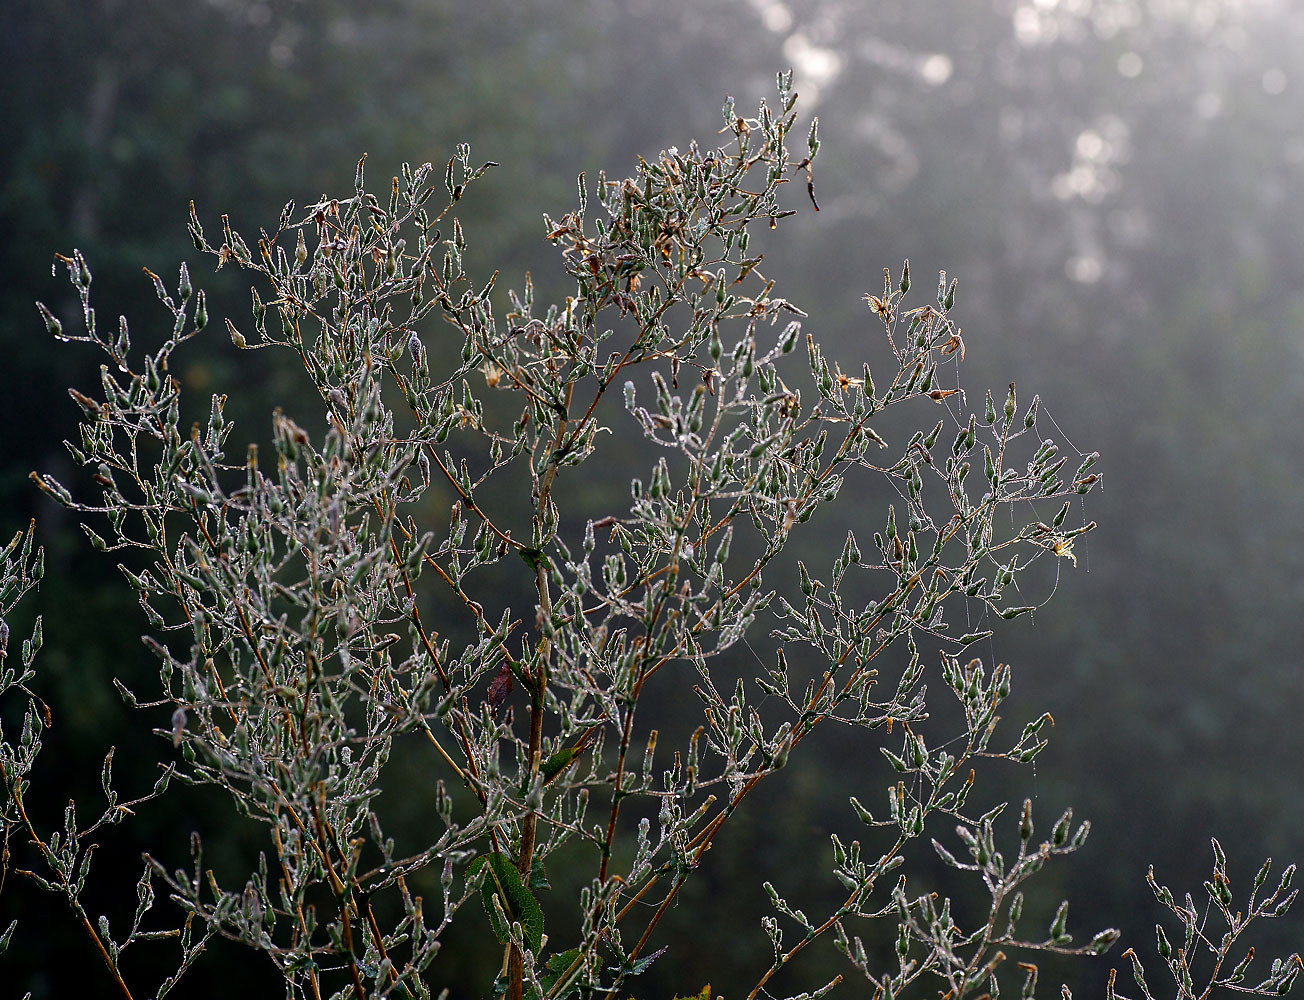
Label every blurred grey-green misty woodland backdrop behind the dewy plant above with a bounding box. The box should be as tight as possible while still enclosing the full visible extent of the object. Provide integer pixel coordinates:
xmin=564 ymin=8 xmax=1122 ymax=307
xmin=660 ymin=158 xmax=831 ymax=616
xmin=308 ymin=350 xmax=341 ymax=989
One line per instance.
xmin=0 ymin=0 xmax=1304 ymax=997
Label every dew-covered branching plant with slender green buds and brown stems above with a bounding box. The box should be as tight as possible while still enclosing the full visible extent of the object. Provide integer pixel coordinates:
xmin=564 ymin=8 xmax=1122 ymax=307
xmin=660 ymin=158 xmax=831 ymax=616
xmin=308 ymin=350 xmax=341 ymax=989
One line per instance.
xmin=0 ymin=74 xmax=1300 ymax=1000
